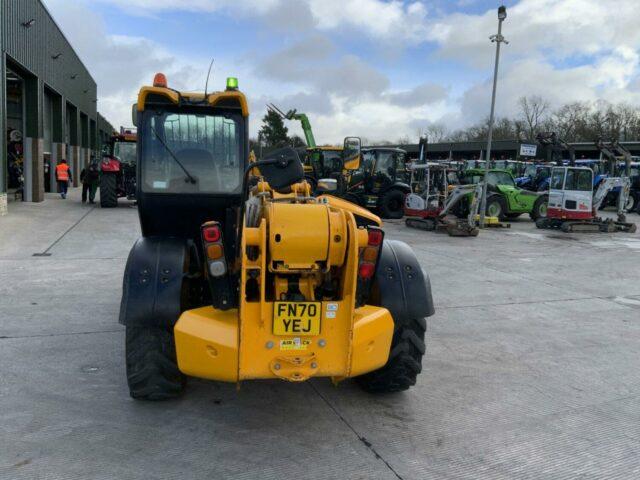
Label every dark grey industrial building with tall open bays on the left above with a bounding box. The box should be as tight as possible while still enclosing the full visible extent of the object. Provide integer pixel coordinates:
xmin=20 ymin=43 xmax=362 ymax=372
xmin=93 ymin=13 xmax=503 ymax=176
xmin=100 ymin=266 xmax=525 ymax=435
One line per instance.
xmin=0 ymin=0 xmax=113 ymax=210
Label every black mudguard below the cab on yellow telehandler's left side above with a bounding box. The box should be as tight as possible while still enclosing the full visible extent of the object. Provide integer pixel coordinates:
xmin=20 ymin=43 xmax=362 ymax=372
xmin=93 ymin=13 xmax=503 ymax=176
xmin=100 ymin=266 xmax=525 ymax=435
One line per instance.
xmin=119 ymin=237 xmax=189 ymax=327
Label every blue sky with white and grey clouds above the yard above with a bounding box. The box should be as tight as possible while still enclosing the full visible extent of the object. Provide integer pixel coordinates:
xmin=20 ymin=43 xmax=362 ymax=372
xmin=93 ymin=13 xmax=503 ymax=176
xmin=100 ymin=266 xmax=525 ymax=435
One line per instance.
xmin=45 ymin=0 xmax=640 ymax=143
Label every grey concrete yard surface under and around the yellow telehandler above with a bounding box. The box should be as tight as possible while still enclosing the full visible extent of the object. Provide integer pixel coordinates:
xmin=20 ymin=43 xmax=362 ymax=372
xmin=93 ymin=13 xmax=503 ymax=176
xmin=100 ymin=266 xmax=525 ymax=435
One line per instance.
xmin=0 ymin=189 xmax=640 ymax=480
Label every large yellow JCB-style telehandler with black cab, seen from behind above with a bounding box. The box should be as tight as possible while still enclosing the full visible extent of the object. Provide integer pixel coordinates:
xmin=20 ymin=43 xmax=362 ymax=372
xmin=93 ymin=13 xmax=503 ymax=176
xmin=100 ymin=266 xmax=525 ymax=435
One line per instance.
xmin=120 ymin=74 xmax=434 ymax=400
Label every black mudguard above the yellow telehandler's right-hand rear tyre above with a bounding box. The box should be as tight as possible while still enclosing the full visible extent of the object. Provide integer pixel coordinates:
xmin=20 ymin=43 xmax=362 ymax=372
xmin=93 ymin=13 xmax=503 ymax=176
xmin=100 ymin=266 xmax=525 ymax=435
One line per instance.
xmin=372 ymin=240 xmax=435 ymax=319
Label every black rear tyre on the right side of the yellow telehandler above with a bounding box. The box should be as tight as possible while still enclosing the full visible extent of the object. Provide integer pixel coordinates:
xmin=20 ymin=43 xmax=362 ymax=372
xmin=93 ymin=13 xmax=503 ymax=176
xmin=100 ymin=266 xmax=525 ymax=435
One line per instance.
xmin=356 ymin=318 xmax=427 ymax=393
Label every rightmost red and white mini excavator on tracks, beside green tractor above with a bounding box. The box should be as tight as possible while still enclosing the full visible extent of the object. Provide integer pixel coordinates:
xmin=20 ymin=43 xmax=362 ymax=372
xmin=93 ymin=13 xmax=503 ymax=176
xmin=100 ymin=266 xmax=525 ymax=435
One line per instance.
xmin=536 ymin=166 xmax=636 ymax=233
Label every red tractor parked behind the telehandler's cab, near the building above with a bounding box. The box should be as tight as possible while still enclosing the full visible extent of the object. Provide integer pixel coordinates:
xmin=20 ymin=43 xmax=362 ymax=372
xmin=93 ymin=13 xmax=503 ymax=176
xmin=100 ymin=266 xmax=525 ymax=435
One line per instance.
xmin=100 ymin=127 xmax=137 ymax=208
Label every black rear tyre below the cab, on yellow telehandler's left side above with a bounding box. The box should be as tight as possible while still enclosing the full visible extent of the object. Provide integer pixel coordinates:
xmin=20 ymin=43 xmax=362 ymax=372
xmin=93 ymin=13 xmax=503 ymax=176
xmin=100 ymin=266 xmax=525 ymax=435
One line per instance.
xmin=125 ymin=326 xmax=185 ymax=400
